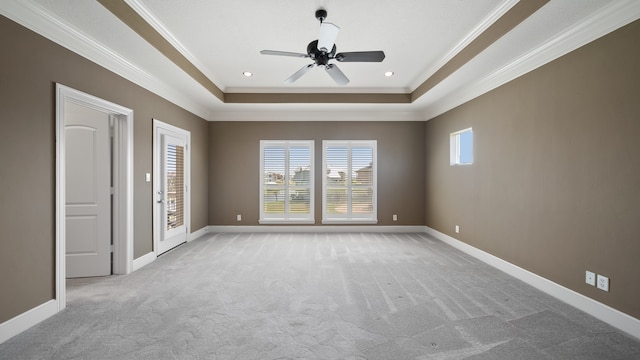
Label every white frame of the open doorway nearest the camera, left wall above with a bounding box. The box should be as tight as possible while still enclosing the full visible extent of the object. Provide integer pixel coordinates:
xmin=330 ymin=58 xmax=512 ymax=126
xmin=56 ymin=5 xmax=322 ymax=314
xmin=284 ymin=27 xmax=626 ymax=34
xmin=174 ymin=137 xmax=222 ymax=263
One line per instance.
xmin=56 ymin=84 xmax=133 ymax=311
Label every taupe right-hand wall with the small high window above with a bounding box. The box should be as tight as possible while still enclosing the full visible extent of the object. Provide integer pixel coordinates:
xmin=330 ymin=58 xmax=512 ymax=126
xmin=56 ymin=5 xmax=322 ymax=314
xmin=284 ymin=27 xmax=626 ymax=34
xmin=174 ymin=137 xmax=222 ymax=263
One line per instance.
xmin=425 ymin=21 xmax=640 ymax=318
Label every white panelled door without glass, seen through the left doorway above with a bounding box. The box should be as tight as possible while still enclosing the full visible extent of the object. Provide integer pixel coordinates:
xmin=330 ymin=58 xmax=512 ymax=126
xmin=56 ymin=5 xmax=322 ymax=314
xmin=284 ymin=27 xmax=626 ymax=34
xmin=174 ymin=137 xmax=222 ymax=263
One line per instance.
xmin=64 ymin=102 xmax=111 ymax=278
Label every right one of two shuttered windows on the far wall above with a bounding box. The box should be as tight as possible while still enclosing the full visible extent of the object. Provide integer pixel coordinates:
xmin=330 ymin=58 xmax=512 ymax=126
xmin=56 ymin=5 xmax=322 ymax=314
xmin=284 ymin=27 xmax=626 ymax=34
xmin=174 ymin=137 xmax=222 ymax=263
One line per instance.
xmin=322 ymin=140 xmax=378 ymax=224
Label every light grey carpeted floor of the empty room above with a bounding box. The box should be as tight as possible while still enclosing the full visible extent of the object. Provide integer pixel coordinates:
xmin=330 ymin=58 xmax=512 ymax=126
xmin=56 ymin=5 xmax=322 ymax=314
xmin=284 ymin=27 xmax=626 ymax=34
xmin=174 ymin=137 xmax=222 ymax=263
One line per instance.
xmin=0 ymin=233 xmax=640 ymax=360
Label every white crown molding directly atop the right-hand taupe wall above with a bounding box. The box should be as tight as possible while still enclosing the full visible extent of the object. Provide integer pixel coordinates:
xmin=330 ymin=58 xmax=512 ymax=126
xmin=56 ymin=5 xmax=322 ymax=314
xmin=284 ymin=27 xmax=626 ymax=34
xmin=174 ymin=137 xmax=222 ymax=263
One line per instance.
xmin=423 ymin=0 xmax=640 ymax=120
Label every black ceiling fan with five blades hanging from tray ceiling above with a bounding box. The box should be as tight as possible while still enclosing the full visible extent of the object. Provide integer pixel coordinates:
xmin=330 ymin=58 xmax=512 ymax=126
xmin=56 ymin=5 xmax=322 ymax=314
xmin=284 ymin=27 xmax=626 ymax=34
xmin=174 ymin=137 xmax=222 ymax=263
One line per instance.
xmin=260 ymin=9 xmax=385 ymax=85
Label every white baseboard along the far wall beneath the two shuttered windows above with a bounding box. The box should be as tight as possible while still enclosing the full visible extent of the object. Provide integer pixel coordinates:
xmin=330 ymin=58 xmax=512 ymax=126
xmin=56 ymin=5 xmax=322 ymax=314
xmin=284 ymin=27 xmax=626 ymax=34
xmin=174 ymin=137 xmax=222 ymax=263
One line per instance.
xmin=207 ymin=225 xmax=425 ymax=233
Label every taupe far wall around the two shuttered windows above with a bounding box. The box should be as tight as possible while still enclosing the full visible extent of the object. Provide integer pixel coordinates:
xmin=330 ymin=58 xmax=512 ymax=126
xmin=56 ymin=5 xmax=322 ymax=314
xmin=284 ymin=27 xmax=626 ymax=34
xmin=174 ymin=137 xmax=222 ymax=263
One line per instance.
xmin=209 ymin=121 xmax=425 ymax=225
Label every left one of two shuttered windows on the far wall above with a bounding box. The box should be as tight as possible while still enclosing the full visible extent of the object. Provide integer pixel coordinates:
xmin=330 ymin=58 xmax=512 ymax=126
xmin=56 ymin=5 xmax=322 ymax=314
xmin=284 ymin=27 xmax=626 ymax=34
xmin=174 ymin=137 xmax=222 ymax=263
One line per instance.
xmin=260 ymin=140 xmax=314 ymax=224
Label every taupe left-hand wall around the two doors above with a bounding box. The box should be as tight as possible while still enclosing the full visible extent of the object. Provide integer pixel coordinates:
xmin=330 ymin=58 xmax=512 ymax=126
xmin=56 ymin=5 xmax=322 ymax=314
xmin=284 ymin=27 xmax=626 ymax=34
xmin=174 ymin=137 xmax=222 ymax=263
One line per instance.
xmin=0 ymin=16 xmax=208 ymax=323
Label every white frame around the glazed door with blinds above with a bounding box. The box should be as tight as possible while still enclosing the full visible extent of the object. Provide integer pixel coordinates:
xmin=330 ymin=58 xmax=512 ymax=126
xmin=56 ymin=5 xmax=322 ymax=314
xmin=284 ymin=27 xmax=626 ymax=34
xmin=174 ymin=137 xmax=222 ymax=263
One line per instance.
xmin=153 ymin=119 xmax=191 ymax=257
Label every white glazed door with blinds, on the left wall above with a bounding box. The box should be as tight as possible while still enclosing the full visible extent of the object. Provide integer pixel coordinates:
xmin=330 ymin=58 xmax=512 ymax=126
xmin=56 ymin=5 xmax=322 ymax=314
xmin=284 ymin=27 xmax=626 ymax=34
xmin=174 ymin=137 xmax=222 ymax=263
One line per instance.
xmin=154 ymin=120 xmax=189 ymax=255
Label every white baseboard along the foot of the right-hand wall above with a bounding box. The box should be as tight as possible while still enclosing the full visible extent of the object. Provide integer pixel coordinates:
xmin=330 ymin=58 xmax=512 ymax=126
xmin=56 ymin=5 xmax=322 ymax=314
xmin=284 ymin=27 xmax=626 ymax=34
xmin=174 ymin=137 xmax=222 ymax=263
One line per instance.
xmin=426 ymin=227 xmax=640 ymax=339
